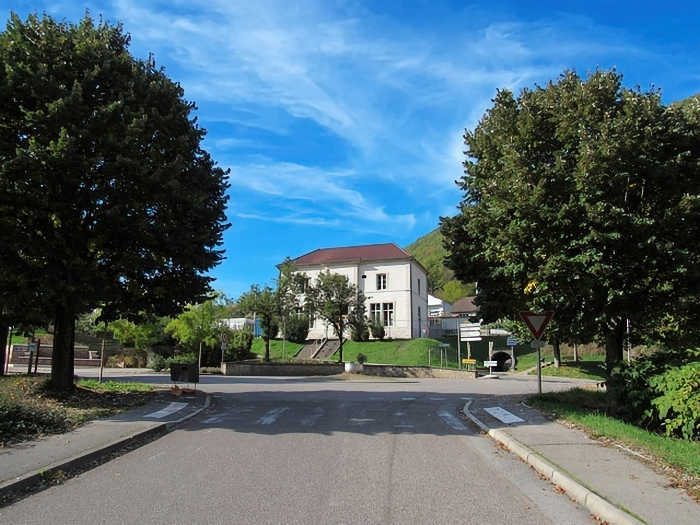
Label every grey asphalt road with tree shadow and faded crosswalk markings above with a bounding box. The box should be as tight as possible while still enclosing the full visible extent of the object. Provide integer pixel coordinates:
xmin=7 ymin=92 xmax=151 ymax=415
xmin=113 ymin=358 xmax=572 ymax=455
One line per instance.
xmin=0 ymin=376 xmax=592 ymax=525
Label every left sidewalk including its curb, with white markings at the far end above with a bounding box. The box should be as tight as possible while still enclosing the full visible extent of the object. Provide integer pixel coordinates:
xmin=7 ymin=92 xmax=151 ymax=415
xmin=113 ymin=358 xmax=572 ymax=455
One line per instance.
xmin=0 ymin=390 xmax=210 ymax=497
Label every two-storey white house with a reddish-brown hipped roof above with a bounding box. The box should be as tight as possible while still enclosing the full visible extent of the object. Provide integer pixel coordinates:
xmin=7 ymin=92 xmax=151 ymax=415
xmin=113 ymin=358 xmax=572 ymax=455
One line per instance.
xmin=292 ymin=243 xmax=428 ymax=339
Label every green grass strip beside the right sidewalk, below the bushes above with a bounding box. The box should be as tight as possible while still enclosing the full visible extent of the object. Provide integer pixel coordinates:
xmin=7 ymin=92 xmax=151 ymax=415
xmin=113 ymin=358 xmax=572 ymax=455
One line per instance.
xmin=527 ymin=388 xmax=700 ymax=501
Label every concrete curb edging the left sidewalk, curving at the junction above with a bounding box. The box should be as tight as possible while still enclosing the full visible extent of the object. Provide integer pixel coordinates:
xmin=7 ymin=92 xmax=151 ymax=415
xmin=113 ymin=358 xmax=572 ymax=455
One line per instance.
xmin=0 ymin=394 xmax=211 ymax=497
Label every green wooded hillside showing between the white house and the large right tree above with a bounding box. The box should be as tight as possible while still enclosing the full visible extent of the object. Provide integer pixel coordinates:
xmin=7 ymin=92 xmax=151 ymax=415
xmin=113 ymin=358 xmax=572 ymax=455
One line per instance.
xmin=406 ymin=228 xmax=474 ymax=303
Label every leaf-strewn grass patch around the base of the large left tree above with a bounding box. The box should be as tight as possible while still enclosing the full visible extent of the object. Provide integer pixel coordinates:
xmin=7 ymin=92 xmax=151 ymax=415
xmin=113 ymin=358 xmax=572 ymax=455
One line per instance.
xmin=0 ymin=374 xmax=153 ymax=448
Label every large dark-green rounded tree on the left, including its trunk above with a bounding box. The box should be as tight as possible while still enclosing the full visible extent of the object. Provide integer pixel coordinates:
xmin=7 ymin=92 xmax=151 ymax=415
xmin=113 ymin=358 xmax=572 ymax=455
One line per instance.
xmin=0 ymin=13 xmax=228 ymax=390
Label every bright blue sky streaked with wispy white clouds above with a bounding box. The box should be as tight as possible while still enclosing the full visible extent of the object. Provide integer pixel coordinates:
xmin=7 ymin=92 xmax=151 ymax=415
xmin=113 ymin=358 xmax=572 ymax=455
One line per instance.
xmin=6 ymin=0 xmax=700 ymax=298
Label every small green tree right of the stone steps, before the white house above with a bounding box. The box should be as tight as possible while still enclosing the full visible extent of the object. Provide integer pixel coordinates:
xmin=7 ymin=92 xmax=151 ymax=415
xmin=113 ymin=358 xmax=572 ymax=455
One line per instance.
xmin=305 ymin=271 xmax=365 ymax=363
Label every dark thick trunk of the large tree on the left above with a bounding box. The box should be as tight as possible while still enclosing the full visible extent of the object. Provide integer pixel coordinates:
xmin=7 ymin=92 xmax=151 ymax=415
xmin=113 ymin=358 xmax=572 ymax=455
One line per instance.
xmin=51 ymin=304 xmax=75 ymax=392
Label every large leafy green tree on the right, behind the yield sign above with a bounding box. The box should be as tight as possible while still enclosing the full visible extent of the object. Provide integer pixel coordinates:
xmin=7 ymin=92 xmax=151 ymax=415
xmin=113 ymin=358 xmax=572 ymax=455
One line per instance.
xmin=441 ymin=67 xmax=700 ymax=404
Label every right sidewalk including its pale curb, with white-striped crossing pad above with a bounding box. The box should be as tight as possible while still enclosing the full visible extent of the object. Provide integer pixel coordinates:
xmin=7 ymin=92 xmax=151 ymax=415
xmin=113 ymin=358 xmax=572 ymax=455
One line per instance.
xmin=463 ymin=399 xmax=700 ymax=525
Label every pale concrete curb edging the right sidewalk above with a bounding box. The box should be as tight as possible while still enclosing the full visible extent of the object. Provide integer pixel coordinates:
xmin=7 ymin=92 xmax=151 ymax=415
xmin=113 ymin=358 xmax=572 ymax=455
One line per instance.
xmin=462 ymin=400 xmax=644 ymax=525
